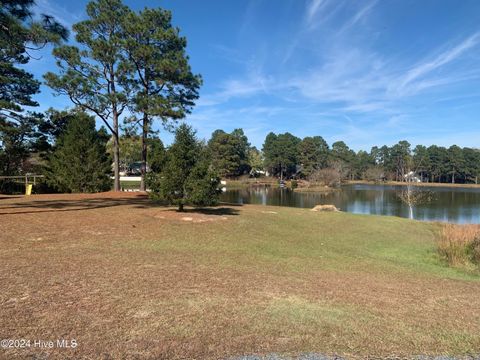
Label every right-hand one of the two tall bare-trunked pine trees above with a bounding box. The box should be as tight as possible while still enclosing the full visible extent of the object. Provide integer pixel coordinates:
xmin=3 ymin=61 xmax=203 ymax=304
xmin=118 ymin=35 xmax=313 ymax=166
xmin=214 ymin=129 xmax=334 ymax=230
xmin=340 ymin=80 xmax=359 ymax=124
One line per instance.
xmin=123 ymin=8 xmax=201 ymax=190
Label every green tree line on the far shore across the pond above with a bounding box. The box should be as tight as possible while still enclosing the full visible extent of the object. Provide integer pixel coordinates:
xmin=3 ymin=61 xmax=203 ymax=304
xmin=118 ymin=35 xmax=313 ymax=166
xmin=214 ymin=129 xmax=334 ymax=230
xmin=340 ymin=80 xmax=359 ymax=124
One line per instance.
xmin=208 ymin=129 xmax=480 ymax=183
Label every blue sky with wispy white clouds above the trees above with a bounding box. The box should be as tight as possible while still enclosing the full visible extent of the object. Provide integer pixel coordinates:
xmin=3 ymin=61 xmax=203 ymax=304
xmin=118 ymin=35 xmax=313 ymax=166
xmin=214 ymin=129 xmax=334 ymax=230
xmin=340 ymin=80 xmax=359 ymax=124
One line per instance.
xmin=28 ymin=0 xmax=480 ymax=150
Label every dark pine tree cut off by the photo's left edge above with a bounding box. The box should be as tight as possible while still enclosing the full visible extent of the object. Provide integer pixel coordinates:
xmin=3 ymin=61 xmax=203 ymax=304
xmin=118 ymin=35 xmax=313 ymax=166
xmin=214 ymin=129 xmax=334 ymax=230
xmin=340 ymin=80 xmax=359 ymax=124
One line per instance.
xmin=0 ymin=0 xmax=68 ymax=175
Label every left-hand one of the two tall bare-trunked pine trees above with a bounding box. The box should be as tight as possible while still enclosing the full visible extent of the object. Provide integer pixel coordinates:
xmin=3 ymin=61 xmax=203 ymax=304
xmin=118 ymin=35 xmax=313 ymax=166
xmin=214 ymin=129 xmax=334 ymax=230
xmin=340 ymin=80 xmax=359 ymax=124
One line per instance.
xmin=44 ymin=0 xmax=129 ymax=191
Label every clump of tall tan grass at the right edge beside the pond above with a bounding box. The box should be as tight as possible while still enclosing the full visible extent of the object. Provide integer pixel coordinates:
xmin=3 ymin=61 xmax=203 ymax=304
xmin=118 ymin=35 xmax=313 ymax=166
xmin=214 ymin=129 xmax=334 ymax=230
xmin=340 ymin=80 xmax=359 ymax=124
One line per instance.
xmin=437 ymin=224 xmax=480 ymax=270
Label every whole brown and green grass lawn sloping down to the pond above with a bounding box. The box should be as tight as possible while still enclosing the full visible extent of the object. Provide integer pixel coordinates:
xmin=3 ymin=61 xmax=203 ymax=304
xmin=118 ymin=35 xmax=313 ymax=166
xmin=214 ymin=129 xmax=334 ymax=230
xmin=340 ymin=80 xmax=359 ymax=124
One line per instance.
xmin=0 ymin=193 xmax=480 ymax=359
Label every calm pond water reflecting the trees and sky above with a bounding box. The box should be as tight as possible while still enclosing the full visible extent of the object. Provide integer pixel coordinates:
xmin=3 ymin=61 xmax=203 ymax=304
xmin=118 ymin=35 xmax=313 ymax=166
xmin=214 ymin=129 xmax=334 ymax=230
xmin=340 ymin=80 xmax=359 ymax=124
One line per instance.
xmin=221 ymin=184 xmax=480 ymax=224
